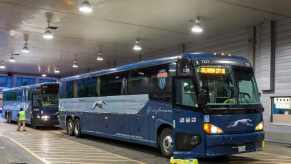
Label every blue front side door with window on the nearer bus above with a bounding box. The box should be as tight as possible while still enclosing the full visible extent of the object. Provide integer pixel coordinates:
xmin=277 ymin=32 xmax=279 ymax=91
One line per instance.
xmin=172 ymin=77 xmax=204 ymax=158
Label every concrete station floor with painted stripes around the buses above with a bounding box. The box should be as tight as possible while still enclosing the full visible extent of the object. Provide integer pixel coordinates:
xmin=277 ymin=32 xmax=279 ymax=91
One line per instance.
xmin=0 ymin=119 xmax=291 ymax=164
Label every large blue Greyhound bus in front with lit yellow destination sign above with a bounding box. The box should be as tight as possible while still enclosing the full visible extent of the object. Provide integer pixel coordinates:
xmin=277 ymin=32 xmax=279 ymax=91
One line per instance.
xmin=59 ymin=53 xmax=264 ymax=157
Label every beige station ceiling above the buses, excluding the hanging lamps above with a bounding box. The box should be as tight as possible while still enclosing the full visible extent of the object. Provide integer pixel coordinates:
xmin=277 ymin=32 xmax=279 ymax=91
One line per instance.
xmin=0 ymin=0 xmax=291 ymax=76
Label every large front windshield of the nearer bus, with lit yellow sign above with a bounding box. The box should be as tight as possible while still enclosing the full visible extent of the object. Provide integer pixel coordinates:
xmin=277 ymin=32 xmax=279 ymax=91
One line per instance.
xmin=198 ymin=67 xmax=259 ymax=105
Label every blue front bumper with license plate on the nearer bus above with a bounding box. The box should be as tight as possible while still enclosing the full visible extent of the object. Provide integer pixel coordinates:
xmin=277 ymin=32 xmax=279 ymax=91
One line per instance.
xmin=205 ymin=132 xmax=264 ymax=157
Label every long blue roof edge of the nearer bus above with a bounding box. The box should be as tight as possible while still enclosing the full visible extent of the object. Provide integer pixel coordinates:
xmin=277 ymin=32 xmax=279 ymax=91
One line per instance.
xmin=60 ymin=52 xmax=249 ymax=81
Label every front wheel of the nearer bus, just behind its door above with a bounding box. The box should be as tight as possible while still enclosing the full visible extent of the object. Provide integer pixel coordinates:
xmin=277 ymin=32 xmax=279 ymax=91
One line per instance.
xmin=159 ymin=128 xmax=174 ymax=157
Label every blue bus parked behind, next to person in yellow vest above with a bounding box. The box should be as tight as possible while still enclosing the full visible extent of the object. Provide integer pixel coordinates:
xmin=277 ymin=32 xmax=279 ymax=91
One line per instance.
xmin=2 ymin=82 xmax=59 ymax=127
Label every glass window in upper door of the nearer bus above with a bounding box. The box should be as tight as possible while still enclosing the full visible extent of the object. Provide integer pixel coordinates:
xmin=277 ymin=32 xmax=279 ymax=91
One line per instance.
xmin=175 ymin=79 xmax=197 ymax=107
